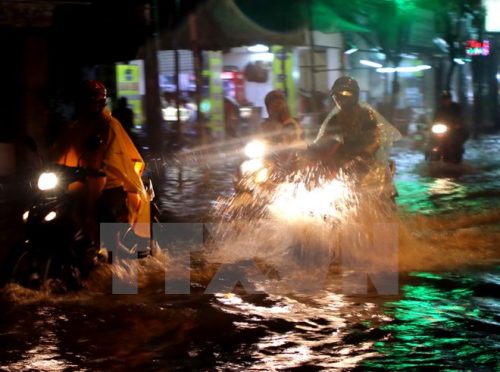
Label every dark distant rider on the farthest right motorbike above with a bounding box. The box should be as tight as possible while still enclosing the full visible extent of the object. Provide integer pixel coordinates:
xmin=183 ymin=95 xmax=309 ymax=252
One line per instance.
xmin=434 ymin=90 xmax=469 ymax=163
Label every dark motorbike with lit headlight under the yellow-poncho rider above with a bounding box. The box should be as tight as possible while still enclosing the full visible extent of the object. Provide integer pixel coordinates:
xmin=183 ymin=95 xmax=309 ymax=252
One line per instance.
xmin=10 ymin=164 xmax=158 ymax=292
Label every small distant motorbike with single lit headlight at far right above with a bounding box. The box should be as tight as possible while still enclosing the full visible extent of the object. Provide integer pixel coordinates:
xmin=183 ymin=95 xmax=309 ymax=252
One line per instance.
xmin=425 ymin=123 xmax=464 ymax=164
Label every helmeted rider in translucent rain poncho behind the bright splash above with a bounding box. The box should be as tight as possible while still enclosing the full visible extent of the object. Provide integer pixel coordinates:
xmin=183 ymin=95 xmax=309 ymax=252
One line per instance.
xmin=306 ymin=76 xmax=401 ymax=206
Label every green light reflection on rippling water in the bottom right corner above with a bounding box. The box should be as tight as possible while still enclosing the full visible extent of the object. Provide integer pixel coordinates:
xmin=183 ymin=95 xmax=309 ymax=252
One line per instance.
xmin=362 ymin=272 xmax=500 ymax=370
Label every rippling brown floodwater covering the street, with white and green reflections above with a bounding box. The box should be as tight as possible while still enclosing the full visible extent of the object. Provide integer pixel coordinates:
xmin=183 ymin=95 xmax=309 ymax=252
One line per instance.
xmin=0 ymin=136 xmax=500 ymax=371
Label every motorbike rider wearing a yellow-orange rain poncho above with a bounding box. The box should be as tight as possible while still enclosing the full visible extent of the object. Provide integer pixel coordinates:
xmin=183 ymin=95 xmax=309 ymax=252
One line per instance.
xmin=54 ymin=80 xmax=150 ymax=254
